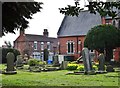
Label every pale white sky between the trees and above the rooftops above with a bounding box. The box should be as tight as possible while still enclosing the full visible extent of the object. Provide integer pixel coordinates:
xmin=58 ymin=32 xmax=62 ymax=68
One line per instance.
xmin=0 ymin=0 xmax=84 ymax=46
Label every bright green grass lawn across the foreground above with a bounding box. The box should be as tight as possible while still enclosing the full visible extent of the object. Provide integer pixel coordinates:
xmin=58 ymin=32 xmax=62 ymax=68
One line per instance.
xmin=2 ymin=66 xmax=120 ymax=86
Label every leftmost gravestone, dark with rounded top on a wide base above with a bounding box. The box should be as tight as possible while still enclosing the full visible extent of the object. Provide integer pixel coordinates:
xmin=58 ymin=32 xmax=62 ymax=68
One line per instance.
xmin=5 ymin=52 xmax=17 ymax=74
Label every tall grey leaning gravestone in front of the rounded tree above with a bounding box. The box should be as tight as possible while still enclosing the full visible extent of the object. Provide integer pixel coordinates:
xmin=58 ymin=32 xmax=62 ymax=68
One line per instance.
xmin=82 ymin=48 xmax=94 ymax=74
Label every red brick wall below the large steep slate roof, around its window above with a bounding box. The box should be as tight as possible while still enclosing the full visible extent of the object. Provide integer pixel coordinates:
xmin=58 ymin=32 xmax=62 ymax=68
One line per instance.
xmin=58 ymin=36 xmax=85 ymax=59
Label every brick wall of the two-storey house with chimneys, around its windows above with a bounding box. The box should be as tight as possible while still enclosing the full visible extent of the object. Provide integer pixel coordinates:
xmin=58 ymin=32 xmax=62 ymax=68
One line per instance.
xmin=14 ymin=35 xmax=58 ymax=55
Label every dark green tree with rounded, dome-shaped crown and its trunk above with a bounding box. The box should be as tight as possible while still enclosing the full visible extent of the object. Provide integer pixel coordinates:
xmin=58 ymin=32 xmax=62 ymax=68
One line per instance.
xmin=84 ymin=24 xmax=120 ymax=62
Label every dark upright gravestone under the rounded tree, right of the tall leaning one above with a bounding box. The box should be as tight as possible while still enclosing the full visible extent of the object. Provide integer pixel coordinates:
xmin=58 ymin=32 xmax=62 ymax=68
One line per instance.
xmin=98 ymin=53 xmax=105 ymax=71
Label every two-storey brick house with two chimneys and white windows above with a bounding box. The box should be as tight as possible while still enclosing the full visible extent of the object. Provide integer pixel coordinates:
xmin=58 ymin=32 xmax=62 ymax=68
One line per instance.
xmin=14 ymin=29 xmax=58 ymax=60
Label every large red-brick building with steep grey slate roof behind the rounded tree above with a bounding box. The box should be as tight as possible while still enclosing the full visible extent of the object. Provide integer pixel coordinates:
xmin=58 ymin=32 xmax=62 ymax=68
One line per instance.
xmin=57 ymin=11 xmax=120 ymax=62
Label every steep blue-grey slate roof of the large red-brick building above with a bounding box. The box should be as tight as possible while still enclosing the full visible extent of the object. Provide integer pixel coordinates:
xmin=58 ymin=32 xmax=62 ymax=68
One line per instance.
xmin=57 ymin=11 xmax=101 ymax=37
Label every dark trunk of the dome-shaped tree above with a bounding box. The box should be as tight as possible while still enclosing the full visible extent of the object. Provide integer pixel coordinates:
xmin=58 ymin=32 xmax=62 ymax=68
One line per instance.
xmin=105 ymin=48 xmax=113 ymax=62
